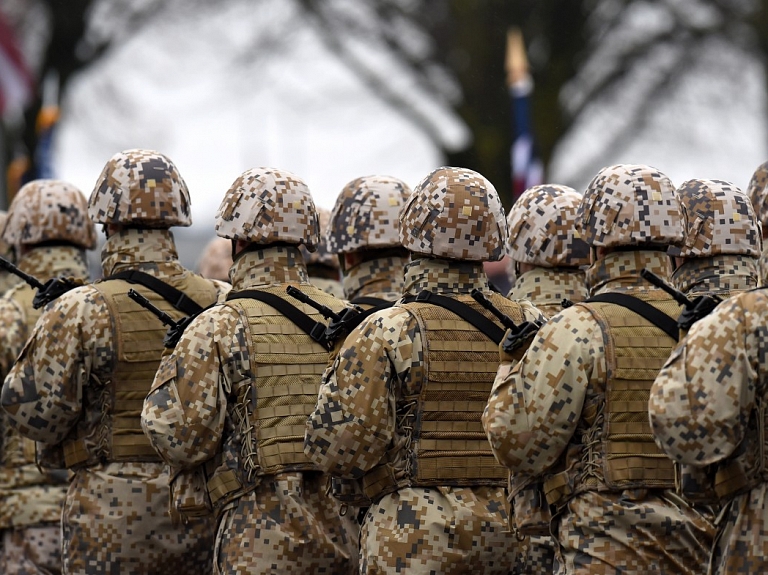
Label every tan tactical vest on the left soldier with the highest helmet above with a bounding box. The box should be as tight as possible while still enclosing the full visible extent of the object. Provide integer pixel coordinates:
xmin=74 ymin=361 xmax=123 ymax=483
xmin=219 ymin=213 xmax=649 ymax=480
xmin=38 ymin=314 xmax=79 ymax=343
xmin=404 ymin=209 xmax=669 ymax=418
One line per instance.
xmin=63 ymin=274 xmax=217 ymax=467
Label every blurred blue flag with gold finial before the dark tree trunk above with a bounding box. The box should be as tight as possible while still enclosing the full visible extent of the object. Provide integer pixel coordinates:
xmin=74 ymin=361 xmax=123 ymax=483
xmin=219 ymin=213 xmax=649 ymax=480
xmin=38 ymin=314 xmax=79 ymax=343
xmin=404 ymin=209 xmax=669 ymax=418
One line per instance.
xmin=505 ymin=28 xmax=544 ymax=205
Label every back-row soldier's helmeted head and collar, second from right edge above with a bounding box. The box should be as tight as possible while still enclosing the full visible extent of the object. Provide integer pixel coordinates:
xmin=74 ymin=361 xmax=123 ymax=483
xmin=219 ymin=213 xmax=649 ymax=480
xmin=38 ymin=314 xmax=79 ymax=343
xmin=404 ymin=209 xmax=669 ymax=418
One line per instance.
xmin=667 ymin=180 xmax=762 ymax=299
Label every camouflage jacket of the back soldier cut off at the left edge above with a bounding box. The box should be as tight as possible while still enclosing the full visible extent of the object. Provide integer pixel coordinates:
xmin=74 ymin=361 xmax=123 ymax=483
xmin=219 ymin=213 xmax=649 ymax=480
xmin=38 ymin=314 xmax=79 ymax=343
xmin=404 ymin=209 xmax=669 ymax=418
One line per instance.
xmin=0 ymin=246 xmax=88 ymax=528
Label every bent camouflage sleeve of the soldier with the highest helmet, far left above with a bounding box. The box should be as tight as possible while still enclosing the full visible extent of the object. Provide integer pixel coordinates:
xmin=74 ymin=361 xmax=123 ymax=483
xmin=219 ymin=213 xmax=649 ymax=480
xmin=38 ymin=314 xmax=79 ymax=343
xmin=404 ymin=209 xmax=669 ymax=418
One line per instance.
xmin=0 ymin=286 xmax=113 ymax=445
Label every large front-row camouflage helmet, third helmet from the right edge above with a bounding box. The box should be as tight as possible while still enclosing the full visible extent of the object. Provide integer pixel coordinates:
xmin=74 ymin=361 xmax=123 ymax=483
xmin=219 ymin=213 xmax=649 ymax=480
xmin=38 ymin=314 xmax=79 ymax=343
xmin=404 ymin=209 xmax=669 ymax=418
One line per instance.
xmin=576 ymin=164 xmax=683 ymax=247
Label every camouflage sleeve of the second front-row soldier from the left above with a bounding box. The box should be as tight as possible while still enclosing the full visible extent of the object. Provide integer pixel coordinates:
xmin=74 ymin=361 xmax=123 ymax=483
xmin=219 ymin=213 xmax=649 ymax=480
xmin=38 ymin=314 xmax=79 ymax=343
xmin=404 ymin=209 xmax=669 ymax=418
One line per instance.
xmin=141 ymin=306 xmax=237 ymax=469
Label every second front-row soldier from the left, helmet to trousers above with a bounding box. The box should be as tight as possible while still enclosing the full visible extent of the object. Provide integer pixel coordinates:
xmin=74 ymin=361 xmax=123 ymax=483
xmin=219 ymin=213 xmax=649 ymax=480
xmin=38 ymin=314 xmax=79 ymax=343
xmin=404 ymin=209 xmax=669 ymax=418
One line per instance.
xmin=142 ymin=168 xmax=357 ymax=575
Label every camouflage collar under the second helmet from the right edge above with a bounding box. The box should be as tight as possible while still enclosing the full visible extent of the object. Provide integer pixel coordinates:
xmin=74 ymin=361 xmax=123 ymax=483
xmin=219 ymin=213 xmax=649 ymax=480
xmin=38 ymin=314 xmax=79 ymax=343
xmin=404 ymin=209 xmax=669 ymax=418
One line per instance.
xmin=672 ymin=254 xmax=760 ymax=299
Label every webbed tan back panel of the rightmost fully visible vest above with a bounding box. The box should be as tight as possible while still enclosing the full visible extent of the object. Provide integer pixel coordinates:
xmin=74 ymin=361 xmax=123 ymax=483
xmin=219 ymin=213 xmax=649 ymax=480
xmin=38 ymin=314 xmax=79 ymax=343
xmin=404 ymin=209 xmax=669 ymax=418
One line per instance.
xmin=589 ymin=299 xmax=680 ymax=490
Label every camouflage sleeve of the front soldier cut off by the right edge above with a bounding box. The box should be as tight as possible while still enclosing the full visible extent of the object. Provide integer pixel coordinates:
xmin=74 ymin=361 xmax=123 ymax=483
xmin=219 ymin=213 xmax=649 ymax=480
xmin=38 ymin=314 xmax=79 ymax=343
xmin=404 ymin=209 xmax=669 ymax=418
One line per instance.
xmin=648 ymin=292 xmax=756 ymax=466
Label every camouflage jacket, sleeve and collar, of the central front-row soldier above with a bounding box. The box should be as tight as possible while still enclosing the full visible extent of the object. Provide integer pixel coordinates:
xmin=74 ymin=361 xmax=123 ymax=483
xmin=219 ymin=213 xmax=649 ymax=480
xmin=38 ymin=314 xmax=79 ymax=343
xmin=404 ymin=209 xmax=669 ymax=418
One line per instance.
xmin=304 ymin=258 xmax=543 ymax=477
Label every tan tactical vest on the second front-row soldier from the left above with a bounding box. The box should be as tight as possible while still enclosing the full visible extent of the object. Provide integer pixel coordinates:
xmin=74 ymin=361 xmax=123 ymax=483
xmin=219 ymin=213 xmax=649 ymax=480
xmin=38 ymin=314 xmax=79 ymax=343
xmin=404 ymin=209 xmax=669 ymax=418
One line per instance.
xmin=208 ymin=285 xmax=344 ymax=504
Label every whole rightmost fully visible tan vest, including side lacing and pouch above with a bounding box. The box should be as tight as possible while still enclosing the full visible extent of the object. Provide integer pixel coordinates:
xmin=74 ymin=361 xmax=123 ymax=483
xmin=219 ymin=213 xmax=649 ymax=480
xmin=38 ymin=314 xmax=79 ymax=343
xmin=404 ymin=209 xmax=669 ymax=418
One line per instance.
xmin=544 ymin=296 xmax=681 ymax=506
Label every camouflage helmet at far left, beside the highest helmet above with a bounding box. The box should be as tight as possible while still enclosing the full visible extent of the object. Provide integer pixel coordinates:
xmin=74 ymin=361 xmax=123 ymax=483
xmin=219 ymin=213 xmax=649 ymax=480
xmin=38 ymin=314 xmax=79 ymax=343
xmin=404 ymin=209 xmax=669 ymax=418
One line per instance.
xmin=2 ymin=180 xmax=96 ymax=249
